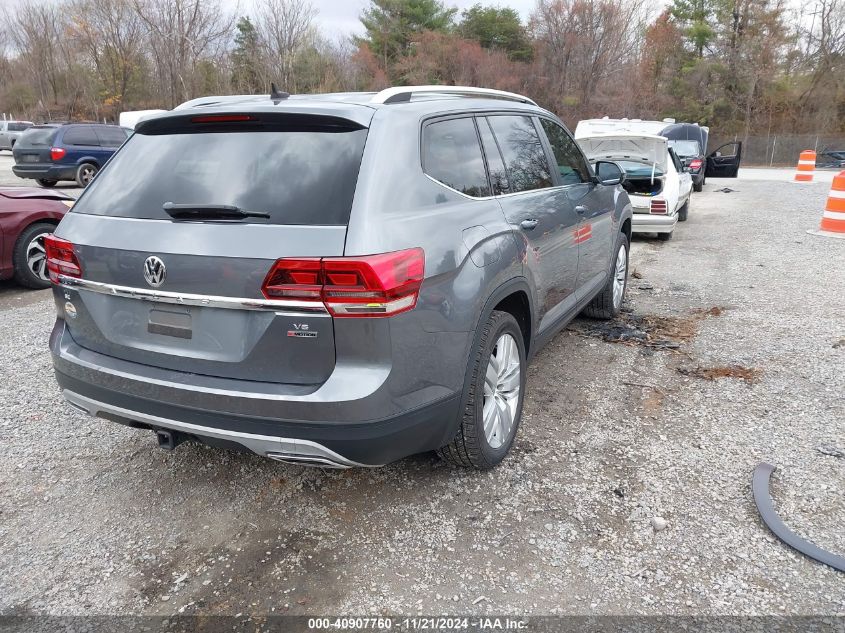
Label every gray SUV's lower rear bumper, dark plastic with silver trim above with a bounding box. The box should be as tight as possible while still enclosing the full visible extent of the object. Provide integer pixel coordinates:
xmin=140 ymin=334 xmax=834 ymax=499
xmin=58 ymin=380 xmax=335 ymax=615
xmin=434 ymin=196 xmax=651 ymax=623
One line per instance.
xmin=50 ymin=320 xmax=460 ymax=467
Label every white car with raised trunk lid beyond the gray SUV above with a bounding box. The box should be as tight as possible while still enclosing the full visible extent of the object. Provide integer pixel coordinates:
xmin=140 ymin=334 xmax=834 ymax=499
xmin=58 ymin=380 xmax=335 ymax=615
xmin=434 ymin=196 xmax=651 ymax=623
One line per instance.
xmin=576 ymin=132 xmax=692 ymax=240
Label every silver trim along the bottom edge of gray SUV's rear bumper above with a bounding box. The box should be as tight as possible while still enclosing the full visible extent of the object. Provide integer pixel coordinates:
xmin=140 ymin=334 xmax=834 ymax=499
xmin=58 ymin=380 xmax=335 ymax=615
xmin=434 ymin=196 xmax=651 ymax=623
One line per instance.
xmin=62 ymin=389 xmax=380 ymax=468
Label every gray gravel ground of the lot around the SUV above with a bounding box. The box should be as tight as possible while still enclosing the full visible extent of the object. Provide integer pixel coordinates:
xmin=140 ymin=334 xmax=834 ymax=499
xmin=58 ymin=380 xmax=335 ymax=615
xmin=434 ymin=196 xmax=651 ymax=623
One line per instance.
xmin=0 ymin=179 xmax=845 ymax=615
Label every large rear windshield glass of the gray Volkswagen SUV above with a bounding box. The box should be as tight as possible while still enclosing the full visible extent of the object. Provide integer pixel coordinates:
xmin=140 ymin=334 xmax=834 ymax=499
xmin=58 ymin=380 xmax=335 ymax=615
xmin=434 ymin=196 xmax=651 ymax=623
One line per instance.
xmin=73 ymin=128 xmax=367 ymax=225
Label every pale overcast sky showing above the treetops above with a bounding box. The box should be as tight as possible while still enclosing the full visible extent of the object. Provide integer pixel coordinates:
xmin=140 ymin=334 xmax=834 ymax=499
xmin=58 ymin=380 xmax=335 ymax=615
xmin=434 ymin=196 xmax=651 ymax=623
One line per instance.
xmin=227 ymin=0 xmax=537 ymax=39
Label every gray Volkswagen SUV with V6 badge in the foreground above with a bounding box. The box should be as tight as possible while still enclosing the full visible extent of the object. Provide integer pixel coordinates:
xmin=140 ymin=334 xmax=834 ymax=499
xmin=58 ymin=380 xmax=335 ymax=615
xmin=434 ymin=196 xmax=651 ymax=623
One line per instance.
xmin=47 ymin=86 xmax=631 ymax=469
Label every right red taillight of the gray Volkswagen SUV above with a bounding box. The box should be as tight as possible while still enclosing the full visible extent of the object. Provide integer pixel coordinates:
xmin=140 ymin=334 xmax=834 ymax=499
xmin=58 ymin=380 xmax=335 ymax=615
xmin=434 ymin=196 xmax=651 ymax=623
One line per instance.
xmin=261 ymin=248 xmax=425 ymax=317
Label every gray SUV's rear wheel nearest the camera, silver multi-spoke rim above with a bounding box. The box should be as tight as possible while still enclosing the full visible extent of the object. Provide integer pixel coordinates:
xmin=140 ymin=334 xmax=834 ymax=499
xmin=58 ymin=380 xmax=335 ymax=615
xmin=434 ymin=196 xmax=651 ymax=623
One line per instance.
xmin=437 ymin=310 xmax=527 ymax=470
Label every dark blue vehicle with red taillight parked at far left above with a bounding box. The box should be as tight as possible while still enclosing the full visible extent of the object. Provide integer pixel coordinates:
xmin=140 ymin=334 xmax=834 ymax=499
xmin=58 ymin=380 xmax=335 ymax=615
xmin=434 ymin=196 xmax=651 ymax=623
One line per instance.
xmin=12 ymin=123 xmax=131 ymax=187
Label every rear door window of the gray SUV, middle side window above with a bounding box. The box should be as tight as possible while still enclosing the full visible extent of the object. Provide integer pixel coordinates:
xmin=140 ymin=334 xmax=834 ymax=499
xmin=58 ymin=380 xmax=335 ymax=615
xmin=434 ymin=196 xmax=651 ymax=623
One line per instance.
xmin=488 ymin=116 xmax=552 ymax=193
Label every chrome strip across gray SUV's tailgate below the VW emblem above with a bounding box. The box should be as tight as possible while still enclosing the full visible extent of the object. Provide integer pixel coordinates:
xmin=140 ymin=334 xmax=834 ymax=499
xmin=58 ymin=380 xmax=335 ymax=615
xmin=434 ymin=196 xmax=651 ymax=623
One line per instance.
xmin=59 ymin=275 xmax=329 ymax=316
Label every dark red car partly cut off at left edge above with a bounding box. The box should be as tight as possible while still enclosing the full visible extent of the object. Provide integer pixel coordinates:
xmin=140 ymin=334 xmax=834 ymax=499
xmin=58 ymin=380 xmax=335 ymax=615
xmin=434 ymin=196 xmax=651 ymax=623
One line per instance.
xmin=0 ymin=187 xmax=74 ymax=288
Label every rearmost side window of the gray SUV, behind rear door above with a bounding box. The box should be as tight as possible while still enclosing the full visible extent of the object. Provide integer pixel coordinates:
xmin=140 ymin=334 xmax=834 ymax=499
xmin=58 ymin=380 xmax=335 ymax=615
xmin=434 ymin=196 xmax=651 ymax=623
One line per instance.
xmin=423 ymin=117 xmax=490 ymax=197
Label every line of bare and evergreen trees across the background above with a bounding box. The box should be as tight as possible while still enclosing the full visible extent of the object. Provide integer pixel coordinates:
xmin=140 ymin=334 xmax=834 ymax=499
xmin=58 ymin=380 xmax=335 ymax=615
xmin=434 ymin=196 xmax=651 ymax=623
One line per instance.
xmin=0 ymin=0 xmax=845 ymax=136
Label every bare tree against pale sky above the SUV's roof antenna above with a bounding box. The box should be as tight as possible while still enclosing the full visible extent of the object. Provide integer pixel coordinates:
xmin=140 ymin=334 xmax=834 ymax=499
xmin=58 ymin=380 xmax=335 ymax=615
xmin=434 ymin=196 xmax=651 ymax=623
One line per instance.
xmin=257 ymin=0 xmax=317 ymax=92
